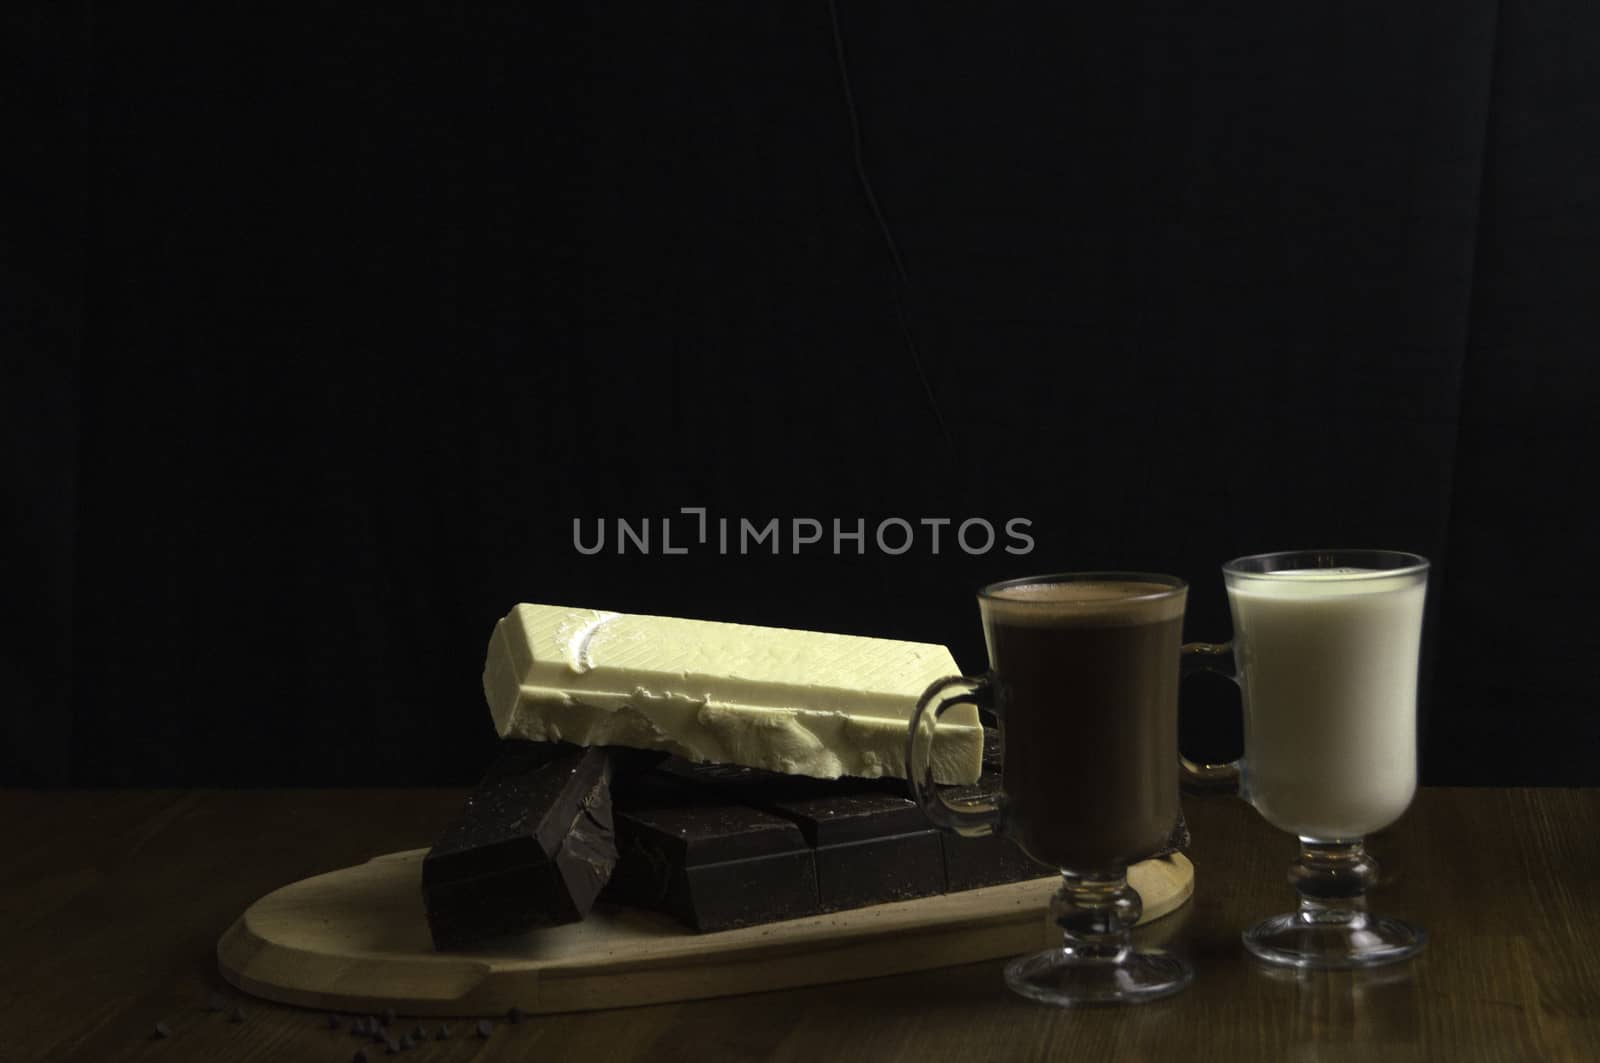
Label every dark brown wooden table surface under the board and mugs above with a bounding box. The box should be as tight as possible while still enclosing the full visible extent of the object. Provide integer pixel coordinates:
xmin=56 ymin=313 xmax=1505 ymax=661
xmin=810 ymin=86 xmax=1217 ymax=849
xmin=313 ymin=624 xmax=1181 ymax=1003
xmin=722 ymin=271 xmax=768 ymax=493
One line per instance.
xmin=0 ymin=789 xmax=1600 ymax=1063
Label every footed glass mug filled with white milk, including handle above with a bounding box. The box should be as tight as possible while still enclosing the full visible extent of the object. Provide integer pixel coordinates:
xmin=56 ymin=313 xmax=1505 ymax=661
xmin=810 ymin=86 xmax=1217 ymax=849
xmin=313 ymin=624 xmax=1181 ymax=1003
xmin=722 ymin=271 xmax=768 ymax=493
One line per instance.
xmin=1181 ymin=551 xmax=1427 ymax=969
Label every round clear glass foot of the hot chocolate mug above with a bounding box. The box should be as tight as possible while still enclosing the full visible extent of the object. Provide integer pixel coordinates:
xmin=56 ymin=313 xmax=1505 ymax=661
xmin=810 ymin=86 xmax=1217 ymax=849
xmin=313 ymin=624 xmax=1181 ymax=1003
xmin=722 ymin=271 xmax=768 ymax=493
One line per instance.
xmin=1005 ymin=948 xmax=1194 ymax=1007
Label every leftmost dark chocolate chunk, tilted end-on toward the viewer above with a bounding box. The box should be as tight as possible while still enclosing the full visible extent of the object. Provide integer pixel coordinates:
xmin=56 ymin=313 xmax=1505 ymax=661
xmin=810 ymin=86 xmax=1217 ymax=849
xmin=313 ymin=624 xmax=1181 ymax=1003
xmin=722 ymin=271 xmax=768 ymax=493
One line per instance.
xmin=422 ymin=743 xmax=616 ymax=949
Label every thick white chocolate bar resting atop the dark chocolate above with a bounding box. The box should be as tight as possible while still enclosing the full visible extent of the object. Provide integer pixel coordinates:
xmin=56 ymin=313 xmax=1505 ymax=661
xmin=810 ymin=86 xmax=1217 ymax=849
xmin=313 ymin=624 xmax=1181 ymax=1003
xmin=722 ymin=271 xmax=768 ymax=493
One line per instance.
xmin=483 ymin=605 xmax=984 ymax=784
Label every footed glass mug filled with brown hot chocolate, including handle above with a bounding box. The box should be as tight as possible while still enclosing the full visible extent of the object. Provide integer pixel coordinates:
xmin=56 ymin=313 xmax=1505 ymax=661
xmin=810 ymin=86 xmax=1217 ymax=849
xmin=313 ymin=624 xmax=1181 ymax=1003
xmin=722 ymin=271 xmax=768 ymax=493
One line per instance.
xmin=906 ymin=572 xmax=1194 ymax=1005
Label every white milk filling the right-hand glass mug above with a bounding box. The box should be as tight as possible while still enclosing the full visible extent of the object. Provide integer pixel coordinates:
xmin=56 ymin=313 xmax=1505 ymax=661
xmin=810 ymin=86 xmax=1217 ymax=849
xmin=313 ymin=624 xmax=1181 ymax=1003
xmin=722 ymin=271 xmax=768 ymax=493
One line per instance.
xmin=1229 ymin=568 xmax=1427 ymax=840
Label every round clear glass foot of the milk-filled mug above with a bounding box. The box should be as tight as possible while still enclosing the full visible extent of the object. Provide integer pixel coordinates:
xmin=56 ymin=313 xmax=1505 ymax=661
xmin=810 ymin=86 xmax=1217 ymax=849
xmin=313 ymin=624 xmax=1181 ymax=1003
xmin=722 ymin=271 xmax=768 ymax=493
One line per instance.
xmin=1243 ymin=909 xmax=1427 ymax=970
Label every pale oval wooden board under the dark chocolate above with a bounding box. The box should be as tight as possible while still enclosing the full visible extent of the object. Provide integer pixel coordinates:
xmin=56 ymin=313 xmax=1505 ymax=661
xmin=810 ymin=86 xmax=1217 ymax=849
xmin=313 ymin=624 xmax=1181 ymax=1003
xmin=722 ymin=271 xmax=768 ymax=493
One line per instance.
xmin=216 ymin=848 xmax=1194 ymax=1017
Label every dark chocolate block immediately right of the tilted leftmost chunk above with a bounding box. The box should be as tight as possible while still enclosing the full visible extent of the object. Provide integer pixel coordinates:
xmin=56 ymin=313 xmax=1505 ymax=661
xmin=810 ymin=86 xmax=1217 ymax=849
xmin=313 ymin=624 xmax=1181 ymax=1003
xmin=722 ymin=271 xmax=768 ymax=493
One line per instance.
xmin=605 ymin=772 xmax=818 ymax=932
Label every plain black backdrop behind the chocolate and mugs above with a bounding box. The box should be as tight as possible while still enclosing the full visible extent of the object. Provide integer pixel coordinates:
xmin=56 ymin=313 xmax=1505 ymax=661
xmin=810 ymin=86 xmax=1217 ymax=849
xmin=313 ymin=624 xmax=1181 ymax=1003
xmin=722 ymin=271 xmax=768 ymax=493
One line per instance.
xmin=0 ymin=0 xmax=1600 ymax=784
